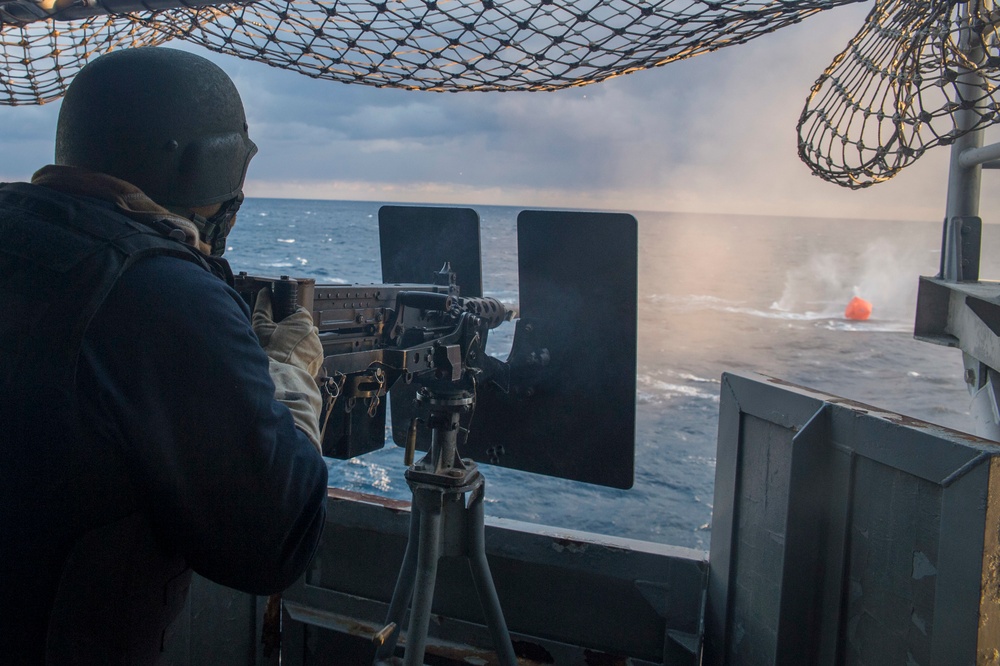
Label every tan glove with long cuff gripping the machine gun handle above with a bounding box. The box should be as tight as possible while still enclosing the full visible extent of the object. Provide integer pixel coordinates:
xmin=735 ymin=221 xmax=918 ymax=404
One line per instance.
xmin=252 ymin=289 xmax=323 ymax=453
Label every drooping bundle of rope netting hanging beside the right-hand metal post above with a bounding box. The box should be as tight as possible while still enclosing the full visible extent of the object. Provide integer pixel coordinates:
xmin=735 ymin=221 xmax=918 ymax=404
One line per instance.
xmin=798 ymin=0 xmax=1000 ymax=188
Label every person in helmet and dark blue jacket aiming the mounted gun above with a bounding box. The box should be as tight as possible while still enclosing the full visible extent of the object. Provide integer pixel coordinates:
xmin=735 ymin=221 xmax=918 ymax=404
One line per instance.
xmin=0 ymin=48 xmax=327 ymax=664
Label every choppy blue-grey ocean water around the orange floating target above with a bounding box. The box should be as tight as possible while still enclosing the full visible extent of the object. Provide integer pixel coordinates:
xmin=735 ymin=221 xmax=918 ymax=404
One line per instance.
xmin=226 ymin=199 xmax=1000 ymax=549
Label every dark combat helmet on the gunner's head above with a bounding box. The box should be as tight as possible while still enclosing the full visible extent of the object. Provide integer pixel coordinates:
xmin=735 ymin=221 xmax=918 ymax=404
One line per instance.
xmin=55 ymin=47 xmax=257 ymax=211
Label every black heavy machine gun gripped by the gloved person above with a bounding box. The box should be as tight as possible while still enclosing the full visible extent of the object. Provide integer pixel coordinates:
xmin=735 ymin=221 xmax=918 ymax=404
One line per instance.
xmin=235 ymin=264 xmax=514 ymax=464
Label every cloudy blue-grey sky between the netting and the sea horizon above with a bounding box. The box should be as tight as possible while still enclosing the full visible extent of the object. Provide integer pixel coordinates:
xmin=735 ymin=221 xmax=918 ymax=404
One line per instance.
xmin=0 ymin=2 xmax=1000 ymax=221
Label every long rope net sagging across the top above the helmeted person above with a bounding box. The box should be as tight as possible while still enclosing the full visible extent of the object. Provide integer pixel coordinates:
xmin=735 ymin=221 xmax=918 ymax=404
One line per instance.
xmin=0 ymin=0 xmax=856 ymax=104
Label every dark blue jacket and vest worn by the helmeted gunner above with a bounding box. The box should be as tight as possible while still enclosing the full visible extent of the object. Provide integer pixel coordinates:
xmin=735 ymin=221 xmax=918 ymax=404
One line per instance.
xmin=0 ymin=179 xmax=327 ymax=664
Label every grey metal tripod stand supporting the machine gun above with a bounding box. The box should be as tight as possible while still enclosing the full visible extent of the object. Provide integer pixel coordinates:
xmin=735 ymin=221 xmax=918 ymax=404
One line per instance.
xmin=375 ymin=391 xmax=517 ymax=666
